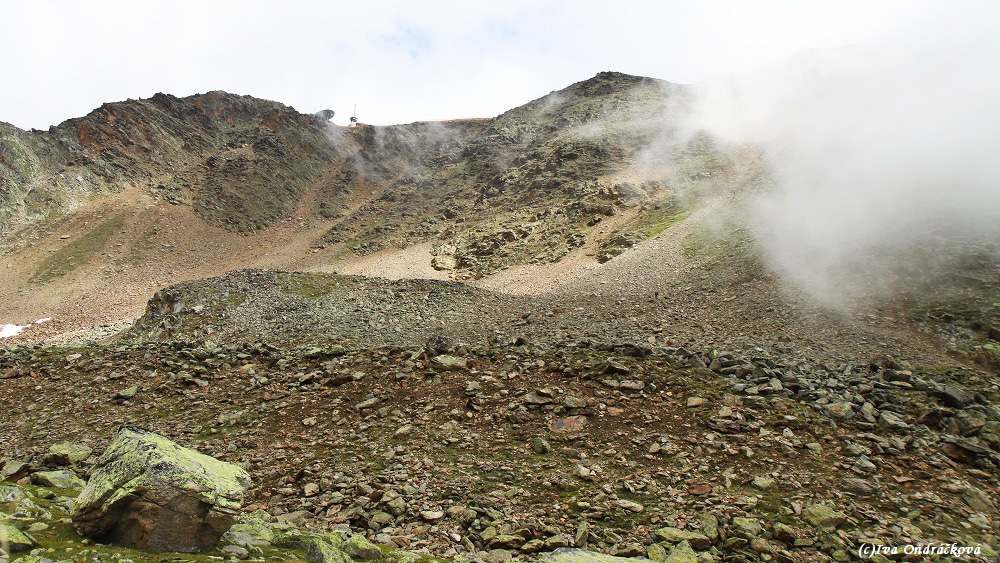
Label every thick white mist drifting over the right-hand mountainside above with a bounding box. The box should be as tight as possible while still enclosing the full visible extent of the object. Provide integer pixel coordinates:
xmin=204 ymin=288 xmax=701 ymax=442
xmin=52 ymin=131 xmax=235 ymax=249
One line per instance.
xmin=696 ymin=4 xmax=1000 ymax=305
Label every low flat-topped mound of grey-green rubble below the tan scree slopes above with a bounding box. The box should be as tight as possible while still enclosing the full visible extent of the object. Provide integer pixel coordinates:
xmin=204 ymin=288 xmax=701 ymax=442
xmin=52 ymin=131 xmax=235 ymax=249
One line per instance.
xmin=127 ymin=270 xmax=509 ymax=348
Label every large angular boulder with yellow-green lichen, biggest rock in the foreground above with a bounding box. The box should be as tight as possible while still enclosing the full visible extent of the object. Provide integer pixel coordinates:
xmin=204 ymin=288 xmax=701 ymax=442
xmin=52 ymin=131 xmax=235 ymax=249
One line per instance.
xmin=72 ymin=426 xmax=250 ymax=552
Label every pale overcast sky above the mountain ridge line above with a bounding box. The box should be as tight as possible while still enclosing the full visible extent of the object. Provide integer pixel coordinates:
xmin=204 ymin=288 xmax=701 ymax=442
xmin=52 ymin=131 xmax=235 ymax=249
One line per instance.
xmin=0 ymin=0 xmax=968 ymax=129
